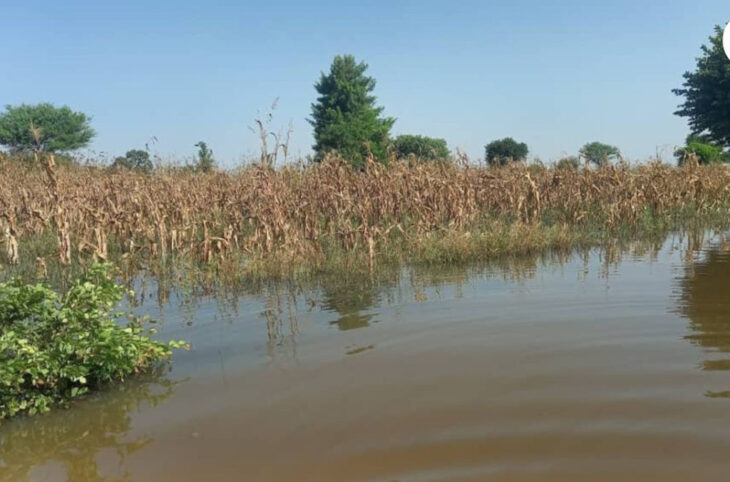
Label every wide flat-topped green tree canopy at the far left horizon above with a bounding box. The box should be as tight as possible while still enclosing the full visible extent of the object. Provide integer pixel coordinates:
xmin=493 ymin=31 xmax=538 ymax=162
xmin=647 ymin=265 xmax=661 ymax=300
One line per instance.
xmin=0 ymin=103 xmax=95 ymax=153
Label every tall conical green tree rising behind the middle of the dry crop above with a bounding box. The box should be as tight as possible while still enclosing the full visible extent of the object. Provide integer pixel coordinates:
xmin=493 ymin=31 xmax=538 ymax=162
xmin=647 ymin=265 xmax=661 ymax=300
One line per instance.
xmin=309 ymin=55 xmax=395 ymax=166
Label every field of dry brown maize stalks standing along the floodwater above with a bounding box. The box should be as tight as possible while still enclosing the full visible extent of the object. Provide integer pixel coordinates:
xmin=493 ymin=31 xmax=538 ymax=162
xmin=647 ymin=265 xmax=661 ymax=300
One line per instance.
xmin=0 ymin=157 xmax=730 ymax=275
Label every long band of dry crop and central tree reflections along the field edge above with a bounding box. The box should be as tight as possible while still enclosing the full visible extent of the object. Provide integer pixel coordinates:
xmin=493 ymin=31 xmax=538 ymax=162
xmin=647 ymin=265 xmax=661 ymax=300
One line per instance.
xmin=109 ymin=236 xmax=672 ymax=336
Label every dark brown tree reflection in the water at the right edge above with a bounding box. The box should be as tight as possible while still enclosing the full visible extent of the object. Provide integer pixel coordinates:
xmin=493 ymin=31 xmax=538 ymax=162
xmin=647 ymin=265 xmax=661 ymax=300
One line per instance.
xmin=679 ymin=237 xmax=730 ymax=397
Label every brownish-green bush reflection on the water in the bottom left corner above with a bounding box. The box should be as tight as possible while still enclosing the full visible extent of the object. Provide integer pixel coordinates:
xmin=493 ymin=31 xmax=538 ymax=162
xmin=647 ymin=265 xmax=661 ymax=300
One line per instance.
xmin=0 ymin=371 xmax=182 ymax=481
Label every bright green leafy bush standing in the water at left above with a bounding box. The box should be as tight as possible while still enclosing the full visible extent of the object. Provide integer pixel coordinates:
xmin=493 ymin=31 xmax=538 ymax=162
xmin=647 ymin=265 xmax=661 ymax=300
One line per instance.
xmin=0 ymin=264 xmax=186 ymax=420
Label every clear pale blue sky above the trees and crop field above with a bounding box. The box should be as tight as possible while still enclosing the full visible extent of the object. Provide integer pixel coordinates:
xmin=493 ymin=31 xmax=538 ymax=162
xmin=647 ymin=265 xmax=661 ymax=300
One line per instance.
xmin=0 ymin=0 xmax=730 ymax=166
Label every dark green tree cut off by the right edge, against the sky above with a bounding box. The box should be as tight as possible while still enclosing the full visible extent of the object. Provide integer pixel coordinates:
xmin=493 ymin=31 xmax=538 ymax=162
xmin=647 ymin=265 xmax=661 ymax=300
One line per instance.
xmin=672 ymin=25 xmax=730 ymax=147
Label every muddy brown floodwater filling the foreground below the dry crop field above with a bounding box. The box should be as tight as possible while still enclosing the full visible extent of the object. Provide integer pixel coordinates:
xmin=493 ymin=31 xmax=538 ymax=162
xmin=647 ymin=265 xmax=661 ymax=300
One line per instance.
xmin=0 ymin=233 xmax=730 ymax=481
